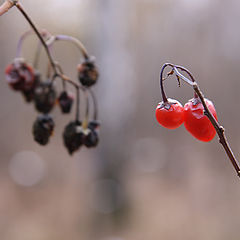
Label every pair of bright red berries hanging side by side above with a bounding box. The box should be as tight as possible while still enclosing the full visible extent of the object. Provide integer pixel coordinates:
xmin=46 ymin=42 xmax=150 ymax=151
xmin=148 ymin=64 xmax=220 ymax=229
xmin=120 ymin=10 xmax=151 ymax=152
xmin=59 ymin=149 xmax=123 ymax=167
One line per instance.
xmin=156 ymin=98 xmax=217 ymax=142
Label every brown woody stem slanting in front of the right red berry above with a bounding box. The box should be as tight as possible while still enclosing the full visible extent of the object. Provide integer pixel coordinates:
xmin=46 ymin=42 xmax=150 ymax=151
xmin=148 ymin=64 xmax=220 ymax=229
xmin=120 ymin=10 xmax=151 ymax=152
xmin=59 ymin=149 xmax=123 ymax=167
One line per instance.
xmin=163 ymin=63 xmax=240 ymax=177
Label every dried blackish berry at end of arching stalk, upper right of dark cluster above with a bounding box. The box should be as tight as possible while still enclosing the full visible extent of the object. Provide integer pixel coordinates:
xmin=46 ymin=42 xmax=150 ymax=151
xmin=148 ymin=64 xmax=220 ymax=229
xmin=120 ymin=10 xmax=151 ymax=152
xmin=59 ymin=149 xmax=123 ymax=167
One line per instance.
xmin=77 ymin=59 xmax=99 ymax=87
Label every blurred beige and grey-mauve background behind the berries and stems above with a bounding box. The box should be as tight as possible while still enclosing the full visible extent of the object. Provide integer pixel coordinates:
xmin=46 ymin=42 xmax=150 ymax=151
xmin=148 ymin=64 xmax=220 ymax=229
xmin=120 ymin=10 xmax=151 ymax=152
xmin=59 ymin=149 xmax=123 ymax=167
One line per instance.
xmin=0 ymin=0 xmax=240 ymax=240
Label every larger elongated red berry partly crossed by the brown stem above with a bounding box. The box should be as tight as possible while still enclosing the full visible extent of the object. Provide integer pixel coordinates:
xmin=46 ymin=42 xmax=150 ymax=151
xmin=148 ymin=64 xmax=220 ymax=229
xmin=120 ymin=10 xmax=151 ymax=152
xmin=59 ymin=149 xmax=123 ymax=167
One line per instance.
xmin=184 ymin=98 xmax=217 ymax=142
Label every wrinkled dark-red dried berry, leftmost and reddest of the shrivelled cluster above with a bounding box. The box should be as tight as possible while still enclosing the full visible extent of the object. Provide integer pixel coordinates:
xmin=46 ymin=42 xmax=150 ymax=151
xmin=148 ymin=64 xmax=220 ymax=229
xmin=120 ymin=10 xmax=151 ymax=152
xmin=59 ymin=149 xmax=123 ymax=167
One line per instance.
xmin=5 ymin=58 xmax=35 ymax=91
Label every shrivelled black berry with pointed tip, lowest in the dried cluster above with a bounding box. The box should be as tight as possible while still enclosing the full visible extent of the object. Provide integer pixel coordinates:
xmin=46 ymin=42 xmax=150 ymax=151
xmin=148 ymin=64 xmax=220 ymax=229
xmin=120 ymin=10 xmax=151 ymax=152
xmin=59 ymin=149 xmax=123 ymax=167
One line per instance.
xmin=63 ymin=121 xmax=84 ymax=155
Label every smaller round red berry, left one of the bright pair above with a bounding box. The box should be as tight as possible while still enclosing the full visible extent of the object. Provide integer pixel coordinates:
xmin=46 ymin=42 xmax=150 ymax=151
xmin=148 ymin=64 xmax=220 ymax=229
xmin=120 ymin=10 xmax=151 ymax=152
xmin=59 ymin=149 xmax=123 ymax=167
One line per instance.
xmin=155 ymin=98 xmax=184 ymax=129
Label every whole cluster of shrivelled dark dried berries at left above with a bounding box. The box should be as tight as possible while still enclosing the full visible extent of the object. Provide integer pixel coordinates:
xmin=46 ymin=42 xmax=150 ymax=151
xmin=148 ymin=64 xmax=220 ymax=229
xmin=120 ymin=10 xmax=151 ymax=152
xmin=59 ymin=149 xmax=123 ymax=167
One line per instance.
xmin=5 ymin=33 xmax=99 ymax=154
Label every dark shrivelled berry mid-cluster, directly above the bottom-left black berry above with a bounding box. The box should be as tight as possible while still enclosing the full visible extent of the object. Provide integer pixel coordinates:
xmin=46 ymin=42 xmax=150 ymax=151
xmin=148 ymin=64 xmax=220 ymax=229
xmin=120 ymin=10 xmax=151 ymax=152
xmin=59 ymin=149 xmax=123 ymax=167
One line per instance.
xmin=34 ymin=82 xmax=56 ymax=113
